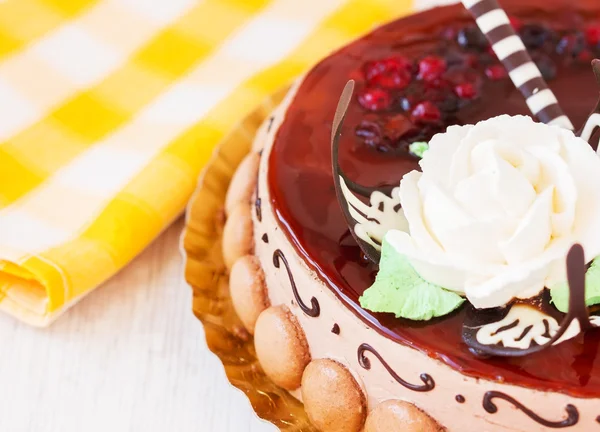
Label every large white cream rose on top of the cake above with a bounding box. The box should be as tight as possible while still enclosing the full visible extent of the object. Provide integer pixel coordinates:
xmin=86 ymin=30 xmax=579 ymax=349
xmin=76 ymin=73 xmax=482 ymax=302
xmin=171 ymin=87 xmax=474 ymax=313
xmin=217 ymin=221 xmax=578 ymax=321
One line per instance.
xmin=386 ymin=115 xmax=600 ymax=308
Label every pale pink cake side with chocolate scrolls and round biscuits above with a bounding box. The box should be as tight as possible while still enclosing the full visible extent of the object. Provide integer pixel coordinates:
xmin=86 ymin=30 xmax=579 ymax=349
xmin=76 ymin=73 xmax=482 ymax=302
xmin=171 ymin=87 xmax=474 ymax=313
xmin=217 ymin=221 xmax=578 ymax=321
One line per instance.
xmin=223 ymin=79 xmax=600 ymax=432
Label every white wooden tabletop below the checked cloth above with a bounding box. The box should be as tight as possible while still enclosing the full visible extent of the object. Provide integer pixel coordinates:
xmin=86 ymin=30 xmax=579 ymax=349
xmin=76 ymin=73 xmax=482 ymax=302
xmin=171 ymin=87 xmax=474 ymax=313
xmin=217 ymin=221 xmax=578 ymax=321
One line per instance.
xmin=0 ymin=220 xmax=277 ymax=432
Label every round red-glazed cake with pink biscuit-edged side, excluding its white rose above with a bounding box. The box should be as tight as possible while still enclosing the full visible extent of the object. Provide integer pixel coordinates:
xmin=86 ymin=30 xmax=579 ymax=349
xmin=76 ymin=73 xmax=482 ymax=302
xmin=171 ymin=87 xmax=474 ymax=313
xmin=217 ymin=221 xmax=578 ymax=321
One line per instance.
xmin=223 ymin=0 xmax=600 ymax=432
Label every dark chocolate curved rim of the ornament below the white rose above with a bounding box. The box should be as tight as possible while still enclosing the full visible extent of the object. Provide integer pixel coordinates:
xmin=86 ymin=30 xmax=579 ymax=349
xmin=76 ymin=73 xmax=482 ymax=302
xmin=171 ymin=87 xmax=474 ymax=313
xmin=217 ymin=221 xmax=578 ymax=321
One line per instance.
xmin=463 ymin=244 xmax=593 ymax=357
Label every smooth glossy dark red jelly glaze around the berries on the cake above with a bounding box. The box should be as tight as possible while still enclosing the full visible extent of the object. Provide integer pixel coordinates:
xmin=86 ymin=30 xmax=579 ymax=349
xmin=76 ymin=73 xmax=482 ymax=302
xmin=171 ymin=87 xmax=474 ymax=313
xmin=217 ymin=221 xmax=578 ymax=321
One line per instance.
xmin=269 ymin=0 xmax=600 ymax=397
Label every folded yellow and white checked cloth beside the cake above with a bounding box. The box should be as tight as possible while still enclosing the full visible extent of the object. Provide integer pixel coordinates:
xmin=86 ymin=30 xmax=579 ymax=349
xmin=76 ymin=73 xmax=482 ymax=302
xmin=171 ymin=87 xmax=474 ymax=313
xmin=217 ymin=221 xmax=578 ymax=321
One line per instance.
xmin=0 ymin=0 xmax=410 ymax=326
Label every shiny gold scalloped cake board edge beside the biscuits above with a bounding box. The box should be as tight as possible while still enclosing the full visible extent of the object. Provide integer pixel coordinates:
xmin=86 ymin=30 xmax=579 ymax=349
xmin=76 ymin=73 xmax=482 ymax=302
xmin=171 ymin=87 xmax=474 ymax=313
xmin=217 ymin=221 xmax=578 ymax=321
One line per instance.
xmin=183 ymin=89 xmax=315 ymax=432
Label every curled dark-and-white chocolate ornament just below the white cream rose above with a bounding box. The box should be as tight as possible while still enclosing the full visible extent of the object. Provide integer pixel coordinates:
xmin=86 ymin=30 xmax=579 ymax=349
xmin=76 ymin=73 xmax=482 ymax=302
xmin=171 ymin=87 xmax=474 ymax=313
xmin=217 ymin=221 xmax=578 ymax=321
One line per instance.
xmin=462 ymin=244 xmax=593 ymax=357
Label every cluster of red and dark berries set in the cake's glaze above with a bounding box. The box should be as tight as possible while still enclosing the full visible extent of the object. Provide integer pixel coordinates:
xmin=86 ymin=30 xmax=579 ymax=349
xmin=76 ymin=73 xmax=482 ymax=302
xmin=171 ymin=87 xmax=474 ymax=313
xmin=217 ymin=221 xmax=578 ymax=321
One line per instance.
xmin=352 ymin=10 xmax=600 ymax=152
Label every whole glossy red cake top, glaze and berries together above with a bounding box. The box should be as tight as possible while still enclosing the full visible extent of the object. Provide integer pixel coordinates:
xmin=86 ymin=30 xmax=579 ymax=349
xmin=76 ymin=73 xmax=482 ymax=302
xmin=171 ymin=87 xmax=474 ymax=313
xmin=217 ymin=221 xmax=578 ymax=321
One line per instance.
xmin=269 ymin=0 xmax=600 ymax=397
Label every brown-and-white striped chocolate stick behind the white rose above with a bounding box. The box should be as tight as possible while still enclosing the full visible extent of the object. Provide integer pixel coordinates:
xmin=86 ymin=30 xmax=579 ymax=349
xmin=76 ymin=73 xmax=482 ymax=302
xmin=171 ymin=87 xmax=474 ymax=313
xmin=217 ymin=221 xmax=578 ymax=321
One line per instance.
xmin=462 ymin=0 xmax=574 ymax=130
